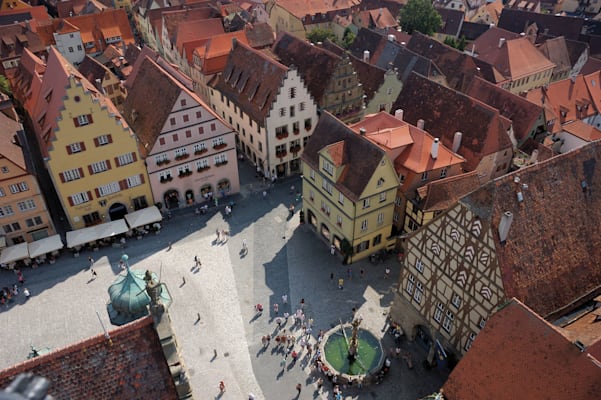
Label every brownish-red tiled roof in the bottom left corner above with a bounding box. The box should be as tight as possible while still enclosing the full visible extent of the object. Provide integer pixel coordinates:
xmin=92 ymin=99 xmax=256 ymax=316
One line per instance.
xmin=0 ymin=316 xmax=178 ymax=400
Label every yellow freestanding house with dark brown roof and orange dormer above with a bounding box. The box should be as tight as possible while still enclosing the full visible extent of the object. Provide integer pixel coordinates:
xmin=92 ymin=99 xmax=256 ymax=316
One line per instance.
xmin=301 ymin=112 xmax=399 ymax=263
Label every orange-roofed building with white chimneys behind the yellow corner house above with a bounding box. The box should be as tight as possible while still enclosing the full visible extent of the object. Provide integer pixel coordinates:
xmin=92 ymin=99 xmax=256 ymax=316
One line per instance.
xmin=350 ymin=110 xmax=465 ymax=234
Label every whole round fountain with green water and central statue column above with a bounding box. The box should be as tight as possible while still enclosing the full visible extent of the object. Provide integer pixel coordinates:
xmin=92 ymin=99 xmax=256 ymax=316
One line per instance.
xmin=321 ymin=316 xmax=384 ymax=384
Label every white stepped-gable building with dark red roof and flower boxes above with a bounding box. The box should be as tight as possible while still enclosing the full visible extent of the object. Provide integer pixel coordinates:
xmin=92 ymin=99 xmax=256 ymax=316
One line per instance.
xmin=209 ymin=41 xmax=317 ymax=177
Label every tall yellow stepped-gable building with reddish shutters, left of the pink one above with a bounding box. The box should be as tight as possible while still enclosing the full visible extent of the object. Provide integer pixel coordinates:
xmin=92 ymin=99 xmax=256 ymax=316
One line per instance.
xmin=24 ymin=48 xmax=152 ymax=229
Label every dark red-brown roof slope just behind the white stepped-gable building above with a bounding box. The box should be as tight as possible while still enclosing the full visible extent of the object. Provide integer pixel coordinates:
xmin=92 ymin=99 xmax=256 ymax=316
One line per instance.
xmin=271 ymin=33 xmax=342 ymax=103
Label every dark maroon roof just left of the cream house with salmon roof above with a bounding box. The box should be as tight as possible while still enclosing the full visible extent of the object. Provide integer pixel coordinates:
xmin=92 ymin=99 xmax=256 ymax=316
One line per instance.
xmin=407 ymin=32 xmax=482 ymax=90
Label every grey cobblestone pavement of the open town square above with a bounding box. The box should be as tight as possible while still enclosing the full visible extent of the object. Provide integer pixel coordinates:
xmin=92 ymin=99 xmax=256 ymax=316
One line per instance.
xmin=0 ymin=162 xmax=447 ymax=400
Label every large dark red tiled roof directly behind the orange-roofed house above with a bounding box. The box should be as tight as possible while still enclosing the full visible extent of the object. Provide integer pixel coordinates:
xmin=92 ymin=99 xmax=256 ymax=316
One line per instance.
xmin=391 ymin=73 xmax=512 ymax=171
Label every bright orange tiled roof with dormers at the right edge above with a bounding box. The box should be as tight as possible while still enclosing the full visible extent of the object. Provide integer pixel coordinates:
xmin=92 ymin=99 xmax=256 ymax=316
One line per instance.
xmin=526 ymin=75 xmax=597 ymax=133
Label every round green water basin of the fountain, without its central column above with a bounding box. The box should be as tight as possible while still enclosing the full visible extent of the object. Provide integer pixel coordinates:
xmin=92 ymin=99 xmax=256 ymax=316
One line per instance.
xmin=322 ymin=325 xmax=384 ymax=381
